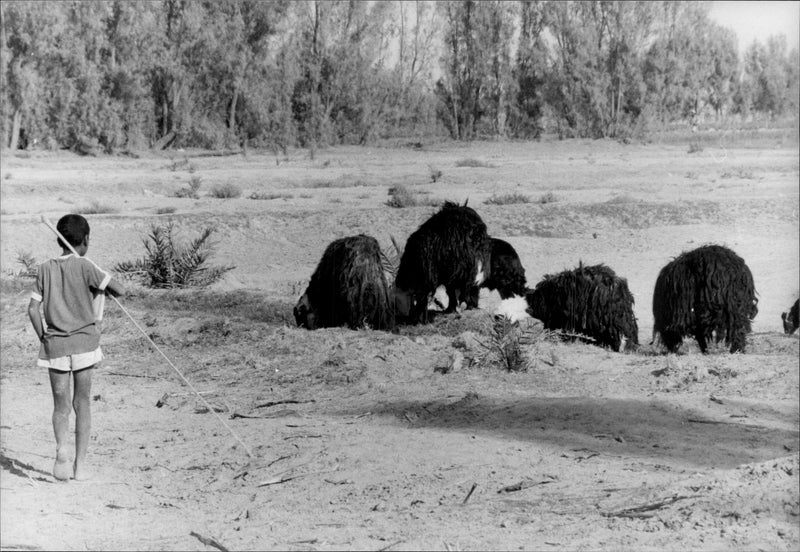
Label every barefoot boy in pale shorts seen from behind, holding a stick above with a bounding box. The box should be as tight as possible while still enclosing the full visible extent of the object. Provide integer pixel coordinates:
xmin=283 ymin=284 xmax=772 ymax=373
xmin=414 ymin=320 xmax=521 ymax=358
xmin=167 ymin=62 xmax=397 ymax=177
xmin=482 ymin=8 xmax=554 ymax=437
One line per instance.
xmin=28 ymin=215 xmax=125 ymax=480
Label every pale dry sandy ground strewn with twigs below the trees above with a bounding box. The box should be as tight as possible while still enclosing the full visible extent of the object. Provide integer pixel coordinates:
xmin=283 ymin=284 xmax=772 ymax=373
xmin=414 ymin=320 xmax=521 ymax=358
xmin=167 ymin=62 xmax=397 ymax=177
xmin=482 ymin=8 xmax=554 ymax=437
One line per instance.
xmin=0 ymin=132 xmax=800 ymax=551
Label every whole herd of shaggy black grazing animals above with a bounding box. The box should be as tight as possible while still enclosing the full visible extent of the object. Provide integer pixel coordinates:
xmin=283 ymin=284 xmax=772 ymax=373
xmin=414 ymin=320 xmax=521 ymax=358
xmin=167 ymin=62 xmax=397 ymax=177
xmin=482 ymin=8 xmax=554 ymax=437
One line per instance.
xmin=294 ymin=201 xmax=800 ymax=353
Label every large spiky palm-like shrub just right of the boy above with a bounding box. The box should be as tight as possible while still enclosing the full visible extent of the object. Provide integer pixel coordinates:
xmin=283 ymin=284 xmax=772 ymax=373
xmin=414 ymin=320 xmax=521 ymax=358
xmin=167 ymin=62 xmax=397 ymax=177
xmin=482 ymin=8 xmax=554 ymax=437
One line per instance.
xmin=115 ymin=221 xmax=235 ymax=288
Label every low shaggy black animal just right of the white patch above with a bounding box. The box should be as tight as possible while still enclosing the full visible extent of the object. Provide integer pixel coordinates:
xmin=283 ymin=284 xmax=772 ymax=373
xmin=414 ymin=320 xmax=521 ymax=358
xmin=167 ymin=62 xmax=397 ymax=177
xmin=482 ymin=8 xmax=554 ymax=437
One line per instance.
xmin=525 ymin=263 xmax=639 ymax=351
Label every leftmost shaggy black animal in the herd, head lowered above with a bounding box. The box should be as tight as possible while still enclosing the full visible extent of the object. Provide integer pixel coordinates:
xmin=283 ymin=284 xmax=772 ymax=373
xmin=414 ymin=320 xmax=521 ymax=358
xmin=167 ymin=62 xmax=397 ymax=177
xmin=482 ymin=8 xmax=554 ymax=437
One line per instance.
xmin=294 ymin=234 xmax=394 ymax=330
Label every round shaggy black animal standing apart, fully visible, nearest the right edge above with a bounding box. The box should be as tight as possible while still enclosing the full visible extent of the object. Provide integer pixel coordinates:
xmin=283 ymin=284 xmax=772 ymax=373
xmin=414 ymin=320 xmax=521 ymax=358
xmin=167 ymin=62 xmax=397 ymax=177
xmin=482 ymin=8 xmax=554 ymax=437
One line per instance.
xmin=653 ymin=245 xmax=758 ymax=353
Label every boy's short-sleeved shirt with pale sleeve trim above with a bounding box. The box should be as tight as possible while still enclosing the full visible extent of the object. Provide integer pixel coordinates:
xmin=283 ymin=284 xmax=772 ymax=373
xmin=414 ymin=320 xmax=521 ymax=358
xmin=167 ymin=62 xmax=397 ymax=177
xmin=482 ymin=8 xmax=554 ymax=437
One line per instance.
xmin=31 ymin=254 xmax=111 ymax=359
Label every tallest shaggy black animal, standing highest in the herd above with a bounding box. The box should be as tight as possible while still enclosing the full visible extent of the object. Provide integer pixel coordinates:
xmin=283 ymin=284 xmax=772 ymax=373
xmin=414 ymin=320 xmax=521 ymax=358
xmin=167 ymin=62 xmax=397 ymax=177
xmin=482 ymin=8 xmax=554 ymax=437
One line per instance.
xmin=394 ymin=201 xmax=491 ymax=324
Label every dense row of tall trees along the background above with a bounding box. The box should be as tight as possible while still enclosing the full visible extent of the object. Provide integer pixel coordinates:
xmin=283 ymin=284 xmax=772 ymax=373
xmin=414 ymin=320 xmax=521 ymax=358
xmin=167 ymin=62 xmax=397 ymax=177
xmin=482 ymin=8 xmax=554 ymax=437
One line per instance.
xmin=0 ymin=0 xmax=800 ymax=154
